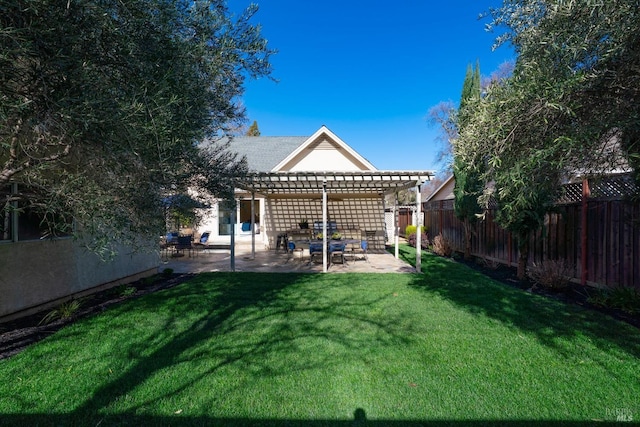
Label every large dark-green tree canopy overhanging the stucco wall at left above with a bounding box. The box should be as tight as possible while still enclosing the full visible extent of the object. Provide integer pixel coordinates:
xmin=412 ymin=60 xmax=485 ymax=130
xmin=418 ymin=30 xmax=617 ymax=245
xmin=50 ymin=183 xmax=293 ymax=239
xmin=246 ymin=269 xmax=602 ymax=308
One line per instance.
xmin=0 ymin=0 xmax=273 ymax=254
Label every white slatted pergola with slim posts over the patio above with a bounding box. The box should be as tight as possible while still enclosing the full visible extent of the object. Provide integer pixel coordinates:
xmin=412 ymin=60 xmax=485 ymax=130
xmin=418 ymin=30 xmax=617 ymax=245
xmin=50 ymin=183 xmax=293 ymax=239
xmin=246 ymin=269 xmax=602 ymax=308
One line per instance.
xmin=231 ymin=171 xmax=434 ymax=272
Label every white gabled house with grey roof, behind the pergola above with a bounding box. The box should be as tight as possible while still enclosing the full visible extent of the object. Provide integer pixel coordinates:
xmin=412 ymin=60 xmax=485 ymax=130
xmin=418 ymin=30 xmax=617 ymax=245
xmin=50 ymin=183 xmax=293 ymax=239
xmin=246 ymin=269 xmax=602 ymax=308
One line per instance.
xmin=197 ymin=126 xmax=433 ymax=258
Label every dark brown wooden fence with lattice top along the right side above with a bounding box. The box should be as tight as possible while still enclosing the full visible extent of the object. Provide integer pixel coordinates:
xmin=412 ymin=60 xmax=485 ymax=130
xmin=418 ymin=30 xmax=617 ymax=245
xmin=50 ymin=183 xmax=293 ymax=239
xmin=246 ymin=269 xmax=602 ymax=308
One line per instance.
xmin=423 ymin=177 xmax=640 ymax=288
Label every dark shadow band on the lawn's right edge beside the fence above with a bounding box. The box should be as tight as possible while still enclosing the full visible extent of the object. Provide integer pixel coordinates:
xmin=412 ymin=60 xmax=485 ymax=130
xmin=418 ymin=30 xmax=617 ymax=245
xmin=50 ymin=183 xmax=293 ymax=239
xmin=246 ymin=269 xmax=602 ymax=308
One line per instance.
xmin=400 ymin=248 xmax=640 ymax=364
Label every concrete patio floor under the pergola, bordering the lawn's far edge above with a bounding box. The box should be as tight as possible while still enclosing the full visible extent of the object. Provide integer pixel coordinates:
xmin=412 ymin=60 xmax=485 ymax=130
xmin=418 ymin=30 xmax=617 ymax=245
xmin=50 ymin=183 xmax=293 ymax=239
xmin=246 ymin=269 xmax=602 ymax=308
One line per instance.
xmin=158 ymin=239 xmax=416 ymax=273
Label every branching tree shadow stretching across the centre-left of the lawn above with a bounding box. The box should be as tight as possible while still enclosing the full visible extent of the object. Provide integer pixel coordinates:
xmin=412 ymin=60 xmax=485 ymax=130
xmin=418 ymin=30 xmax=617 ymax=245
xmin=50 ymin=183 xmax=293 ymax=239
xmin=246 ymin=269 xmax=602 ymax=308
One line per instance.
xmin=63 ymin=273 xmax=416 ymax=425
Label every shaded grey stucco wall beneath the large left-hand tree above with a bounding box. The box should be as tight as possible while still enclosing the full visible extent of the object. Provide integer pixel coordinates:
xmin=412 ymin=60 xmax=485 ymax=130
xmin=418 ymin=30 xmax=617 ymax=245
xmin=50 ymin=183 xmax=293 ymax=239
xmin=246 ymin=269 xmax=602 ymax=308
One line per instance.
xmin=0 ymin=189 xmax=158 ymax=321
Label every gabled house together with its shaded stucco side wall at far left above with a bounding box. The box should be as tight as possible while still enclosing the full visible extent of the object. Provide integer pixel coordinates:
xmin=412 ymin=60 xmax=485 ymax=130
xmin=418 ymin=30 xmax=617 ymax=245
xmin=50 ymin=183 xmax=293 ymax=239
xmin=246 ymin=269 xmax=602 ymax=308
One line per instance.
xmin=0 ymin=126 xmax=432 ymax=321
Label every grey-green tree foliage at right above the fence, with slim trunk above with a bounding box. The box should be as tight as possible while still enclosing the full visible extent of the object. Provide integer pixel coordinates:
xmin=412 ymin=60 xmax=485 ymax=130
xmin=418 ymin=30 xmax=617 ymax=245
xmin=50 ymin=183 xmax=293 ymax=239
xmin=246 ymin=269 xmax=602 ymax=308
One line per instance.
xmin=455 ymin=0 xmax=640 ymax=276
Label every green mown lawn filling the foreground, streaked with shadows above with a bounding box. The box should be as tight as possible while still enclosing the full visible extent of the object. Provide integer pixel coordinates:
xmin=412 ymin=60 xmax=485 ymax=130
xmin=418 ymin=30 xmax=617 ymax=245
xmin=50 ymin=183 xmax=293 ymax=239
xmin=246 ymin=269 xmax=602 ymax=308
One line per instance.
xmin=0 ymin=247 xmax=640 ymax=426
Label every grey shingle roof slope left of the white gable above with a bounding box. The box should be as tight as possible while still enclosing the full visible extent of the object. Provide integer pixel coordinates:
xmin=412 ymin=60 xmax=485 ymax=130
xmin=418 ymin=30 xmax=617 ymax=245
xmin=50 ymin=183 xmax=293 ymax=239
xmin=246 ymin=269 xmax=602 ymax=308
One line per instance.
xmin=222 ymin=136 xmax=309 ymax=172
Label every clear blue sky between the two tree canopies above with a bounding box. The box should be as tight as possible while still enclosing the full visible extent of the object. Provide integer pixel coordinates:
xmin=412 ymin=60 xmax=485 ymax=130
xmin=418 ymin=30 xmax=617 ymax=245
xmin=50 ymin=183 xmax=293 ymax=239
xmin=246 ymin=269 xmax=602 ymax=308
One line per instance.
xmin=234 ymin=0 xmax=514 ymax=170
